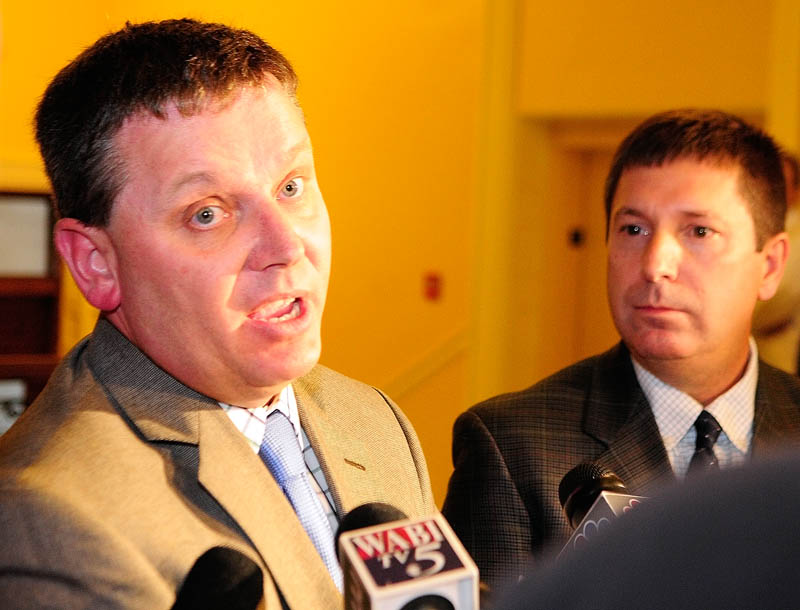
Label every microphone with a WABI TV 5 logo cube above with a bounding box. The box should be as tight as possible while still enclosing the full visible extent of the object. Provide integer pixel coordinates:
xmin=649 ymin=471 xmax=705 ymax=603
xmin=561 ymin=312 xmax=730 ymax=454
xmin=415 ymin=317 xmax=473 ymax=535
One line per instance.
xmin=336 ymin=502 xmax=478 ymax=610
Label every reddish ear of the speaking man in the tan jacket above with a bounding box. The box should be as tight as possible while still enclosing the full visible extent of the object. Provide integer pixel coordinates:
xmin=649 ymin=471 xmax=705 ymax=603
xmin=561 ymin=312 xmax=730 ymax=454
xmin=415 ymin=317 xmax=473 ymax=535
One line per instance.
xmin=53 ymin=218 xmax=120 ymax=311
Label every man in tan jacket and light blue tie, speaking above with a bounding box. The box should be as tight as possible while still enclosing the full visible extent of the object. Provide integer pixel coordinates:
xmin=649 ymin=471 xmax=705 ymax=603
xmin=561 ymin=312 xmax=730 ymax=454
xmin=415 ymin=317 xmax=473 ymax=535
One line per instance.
xmin=0 ymin=20 xmax=434 ymax=608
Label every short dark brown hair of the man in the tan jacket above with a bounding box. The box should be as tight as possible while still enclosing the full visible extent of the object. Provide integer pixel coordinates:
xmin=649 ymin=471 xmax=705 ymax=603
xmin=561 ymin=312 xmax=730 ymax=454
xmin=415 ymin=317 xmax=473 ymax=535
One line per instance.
xmin=36 ymin=19 xmax=297 ymax=226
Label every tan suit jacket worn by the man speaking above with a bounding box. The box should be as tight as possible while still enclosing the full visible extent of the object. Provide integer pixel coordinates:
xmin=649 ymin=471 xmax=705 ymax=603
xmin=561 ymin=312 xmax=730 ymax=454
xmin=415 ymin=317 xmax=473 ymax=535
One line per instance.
xmin=0 ymin=320 xmax=435 ymax=609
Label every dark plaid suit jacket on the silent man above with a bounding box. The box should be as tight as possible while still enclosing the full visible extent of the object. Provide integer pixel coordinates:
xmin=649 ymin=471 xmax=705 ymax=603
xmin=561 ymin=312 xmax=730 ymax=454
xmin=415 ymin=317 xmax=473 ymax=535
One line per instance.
xmin=442 ymin=344 xmax=800 ymax=586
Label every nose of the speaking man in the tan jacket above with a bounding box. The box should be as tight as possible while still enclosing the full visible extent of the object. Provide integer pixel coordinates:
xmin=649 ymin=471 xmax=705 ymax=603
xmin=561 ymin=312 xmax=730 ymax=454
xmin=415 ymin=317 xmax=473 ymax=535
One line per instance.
xmin=248 ymin=201 xmax=305 ymax=269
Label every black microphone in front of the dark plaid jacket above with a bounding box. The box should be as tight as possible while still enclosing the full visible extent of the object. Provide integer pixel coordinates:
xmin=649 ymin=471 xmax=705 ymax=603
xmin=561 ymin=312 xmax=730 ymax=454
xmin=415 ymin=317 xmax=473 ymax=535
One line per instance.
xmin=558 ymin=462 xmax=645 ymax=559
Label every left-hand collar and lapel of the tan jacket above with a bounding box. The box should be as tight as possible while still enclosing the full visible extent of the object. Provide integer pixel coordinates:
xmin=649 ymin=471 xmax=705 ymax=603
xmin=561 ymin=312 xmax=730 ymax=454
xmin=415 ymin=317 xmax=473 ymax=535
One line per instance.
xmin=89 ymin=319 xmax=341 ymax=608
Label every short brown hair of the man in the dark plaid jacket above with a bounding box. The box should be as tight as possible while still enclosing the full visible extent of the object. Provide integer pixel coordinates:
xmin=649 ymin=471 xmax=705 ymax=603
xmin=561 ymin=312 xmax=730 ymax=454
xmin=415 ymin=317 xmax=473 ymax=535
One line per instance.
xmin=605 ymin=109 xmax=786 ymax=250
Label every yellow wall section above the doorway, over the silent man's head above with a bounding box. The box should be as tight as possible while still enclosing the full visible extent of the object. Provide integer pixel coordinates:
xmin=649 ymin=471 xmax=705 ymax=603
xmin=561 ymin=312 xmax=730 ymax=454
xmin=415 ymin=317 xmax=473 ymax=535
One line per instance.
xmin=518 ymin=0 xmax=773 ymax=116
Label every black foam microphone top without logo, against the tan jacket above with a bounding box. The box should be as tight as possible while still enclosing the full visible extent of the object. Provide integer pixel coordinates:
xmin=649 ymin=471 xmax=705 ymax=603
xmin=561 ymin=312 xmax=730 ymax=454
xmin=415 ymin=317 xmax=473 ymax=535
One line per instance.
xmin=172 ymin=546 xmax=264 ymax=610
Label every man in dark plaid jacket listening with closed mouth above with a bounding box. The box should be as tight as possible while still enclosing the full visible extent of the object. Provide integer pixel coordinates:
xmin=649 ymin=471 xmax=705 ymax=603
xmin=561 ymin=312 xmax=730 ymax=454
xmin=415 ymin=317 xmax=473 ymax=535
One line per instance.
xmin=443 ymin=110 xmax=800 ymax=584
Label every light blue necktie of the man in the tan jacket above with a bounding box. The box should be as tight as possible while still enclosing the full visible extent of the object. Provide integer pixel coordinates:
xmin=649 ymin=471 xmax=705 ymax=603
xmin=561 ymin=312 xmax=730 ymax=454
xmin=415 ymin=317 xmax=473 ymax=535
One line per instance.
xmin=258 ymin=411 xmax=342 ymax=591
